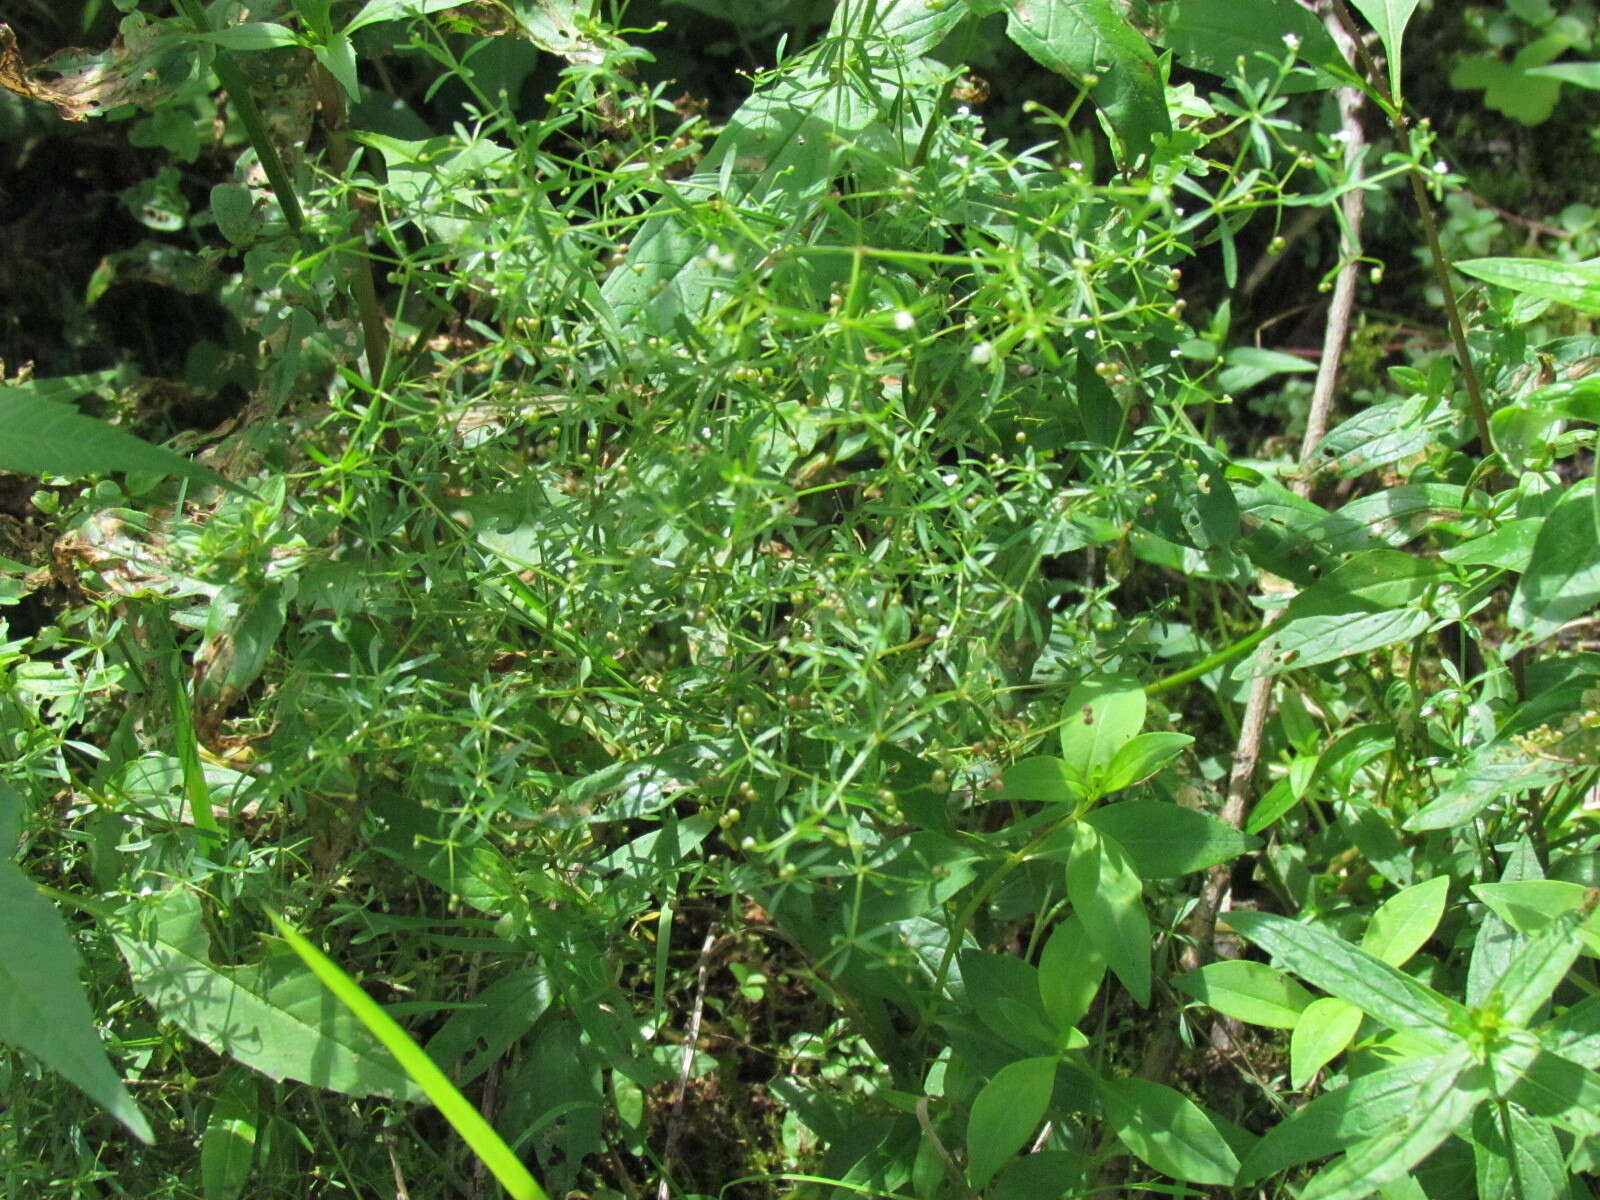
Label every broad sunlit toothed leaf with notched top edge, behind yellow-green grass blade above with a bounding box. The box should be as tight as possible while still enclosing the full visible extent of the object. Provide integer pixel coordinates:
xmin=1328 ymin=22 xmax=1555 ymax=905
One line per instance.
xmin=114 ymin=886 xmax=418 ymax=1101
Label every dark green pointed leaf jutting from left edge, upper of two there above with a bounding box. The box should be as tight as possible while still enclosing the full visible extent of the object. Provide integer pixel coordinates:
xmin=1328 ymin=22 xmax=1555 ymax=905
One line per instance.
xmin=0 ymin=379 xmax=242 ymax=491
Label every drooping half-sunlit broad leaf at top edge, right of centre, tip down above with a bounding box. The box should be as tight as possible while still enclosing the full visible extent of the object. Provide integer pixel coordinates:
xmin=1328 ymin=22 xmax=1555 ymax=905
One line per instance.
xmin=1005 ymin=0 xmax=1171 ymax=165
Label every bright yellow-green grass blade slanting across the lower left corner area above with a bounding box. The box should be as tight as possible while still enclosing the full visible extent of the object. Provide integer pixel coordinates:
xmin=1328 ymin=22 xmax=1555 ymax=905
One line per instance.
xmin=267 ymin=909 xmax=549 ymax=1200
